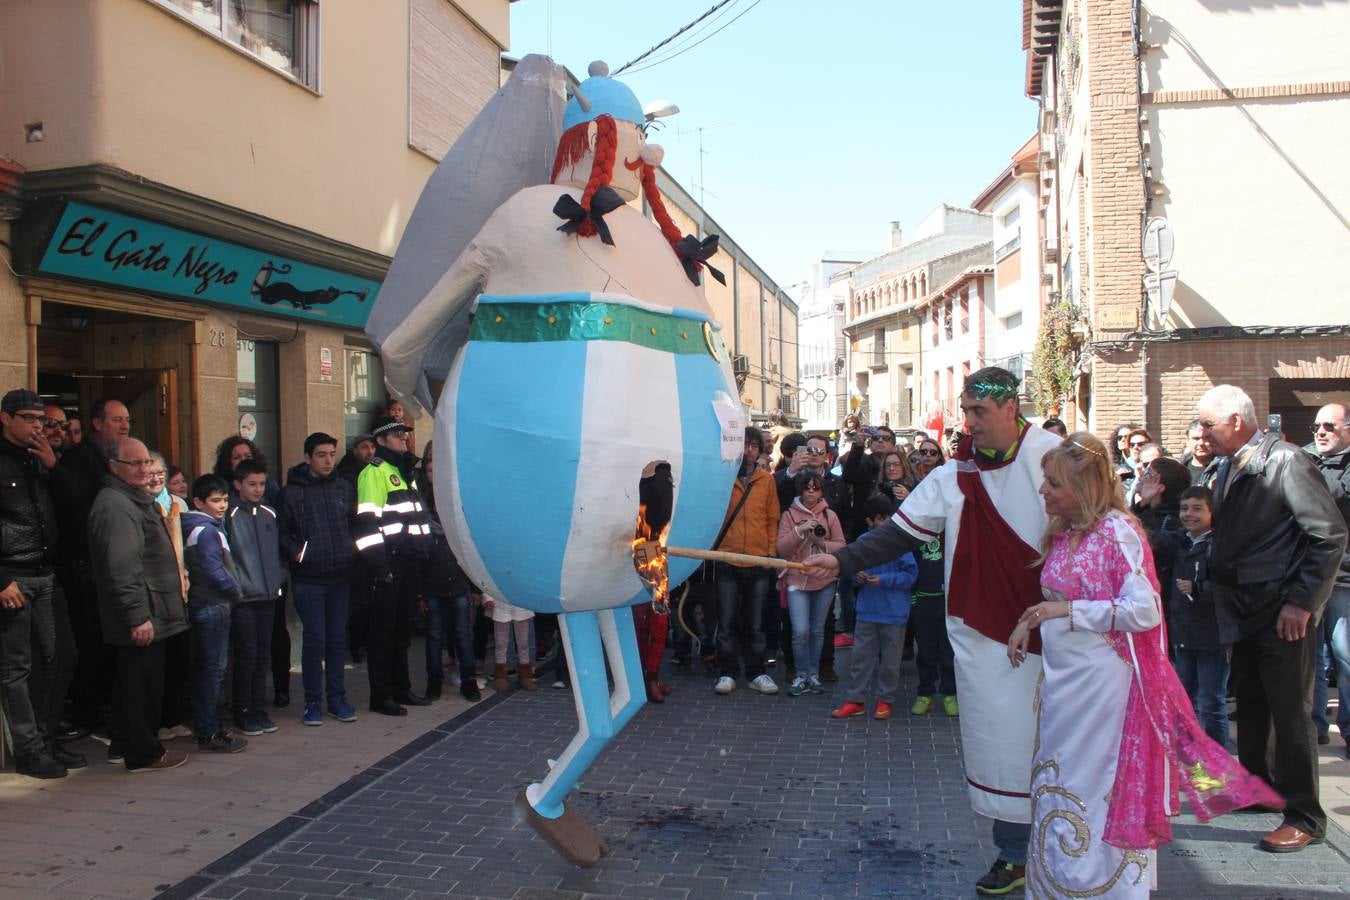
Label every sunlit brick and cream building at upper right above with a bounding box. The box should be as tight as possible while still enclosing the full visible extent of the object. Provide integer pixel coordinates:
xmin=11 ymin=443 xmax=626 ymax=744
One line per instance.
xmin=1022 ymin=0 xmax=1350 ymax=448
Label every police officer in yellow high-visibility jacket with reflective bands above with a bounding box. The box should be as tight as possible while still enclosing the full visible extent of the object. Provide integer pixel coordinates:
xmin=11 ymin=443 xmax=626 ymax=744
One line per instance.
xmin=352 ymin=416 xmax=432 ymax=715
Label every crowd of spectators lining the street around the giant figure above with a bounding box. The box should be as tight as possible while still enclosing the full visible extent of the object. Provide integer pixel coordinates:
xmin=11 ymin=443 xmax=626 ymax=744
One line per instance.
xmin=0 ymin=389 xmax=1350 ymax=826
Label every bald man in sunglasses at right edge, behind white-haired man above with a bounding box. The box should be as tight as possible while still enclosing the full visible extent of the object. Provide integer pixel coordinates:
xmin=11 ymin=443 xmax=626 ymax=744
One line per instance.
xmin=1304 ymin=403 xmax=1350 ymax=758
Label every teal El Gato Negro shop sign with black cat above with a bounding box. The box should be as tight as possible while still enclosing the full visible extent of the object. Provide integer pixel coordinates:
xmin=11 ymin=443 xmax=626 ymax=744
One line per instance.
xmin=36 ymin=201 xmax=379 ymax=328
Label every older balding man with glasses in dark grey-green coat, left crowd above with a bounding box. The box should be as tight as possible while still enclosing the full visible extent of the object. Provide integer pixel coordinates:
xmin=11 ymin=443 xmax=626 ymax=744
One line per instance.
xmin=89 ymin=437 xmax=188 ymax=772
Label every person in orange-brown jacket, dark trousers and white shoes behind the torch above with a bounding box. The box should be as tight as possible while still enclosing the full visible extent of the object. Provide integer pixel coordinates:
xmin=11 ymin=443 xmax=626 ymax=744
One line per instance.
xmin=713 ymin=428 xmax=779 ymax=694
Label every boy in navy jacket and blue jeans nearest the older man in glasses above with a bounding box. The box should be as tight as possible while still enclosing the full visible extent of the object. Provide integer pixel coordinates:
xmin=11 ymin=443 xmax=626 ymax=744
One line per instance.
xmin=182 ymin=475 xmax=248 ymax=753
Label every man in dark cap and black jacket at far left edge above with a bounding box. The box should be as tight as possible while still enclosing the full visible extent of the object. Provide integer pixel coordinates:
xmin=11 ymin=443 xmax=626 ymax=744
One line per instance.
xmin=0 ymin=390 xmax=84 ymax=779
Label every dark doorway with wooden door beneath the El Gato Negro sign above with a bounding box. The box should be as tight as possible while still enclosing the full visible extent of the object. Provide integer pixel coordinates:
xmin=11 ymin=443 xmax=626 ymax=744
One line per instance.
xmin=38 ymin=304 xmax=194 ymax=466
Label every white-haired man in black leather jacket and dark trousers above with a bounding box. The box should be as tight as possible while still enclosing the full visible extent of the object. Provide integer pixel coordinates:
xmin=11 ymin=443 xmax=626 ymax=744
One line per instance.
xmin=1199 ymin=385 xmax=1346 ymax=853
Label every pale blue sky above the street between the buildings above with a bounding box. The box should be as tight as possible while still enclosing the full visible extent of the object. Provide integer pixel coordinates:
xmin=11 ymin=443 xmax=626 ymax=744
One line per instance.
xmin=510 ymin=0 xmax=1035 ymax=287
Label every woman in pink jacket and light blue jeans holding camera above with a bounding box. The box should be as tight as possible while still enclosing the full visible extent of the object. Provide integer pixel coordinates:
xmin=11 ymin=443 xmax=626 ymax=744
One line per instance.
xmin=778 ymin=470 xmax=844 ymax=696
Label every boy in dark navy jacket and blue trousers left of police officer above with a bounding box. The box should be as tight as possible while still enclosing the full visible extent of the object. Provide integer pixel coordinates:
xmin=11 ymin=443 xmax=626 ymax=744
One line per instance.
xmin=277 ymin=432 xmax=356 ymax=726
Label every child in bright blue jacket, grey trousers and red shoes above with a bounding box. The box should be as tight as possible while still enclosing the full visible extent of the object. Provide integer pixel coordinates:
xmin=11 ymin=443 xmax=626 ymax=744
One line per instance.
xmin=830 ymin=494 xmax=918 ymax=719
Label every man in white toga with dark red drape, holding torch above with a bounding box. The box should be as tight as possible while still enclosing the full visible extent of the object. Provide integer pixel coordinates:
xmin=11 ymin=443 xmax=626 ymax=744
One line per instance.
xmin=806 ymin=366 xmax=1062 ymax=895
